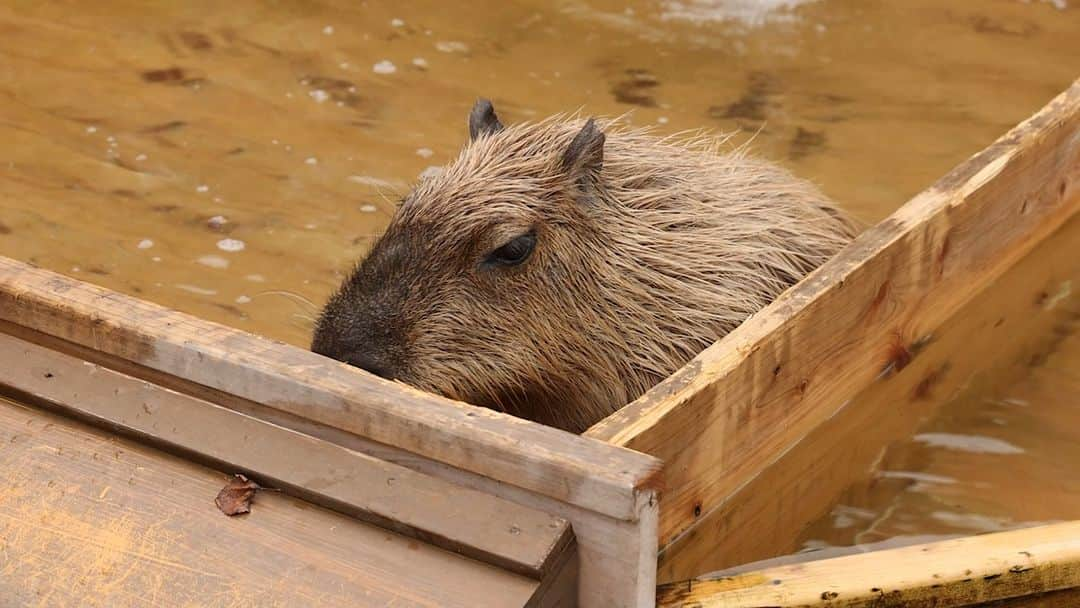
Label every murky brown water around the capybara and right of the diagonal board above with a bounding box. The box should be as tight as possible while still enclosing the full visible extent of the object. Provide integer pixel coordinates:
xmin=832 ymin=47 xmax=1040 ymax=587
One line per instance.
xmin=0 ymin=0 xmax=1080 ymax=570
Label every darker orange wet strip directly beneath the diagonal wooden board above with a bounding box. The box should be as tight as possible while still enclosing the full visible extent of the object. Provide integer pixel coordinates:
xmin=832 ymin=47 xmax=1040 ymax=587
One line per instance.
xmin=657 ymin=216 xmax=1080 ymax=582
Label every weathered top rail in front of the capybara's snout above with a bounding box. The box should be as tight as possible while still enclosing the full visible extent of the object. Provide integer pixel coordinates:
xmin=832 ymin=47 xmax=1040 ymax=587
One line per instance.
xmin=0 ymin=258 xmax=660 ymax=519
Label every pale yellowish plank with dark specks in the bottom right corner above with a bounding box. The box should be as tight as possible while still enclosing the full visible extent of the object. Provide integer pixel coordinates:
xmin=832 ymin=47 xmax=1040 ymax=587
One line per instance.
xmin=657 ymin=522 xmax=1080 ymax=608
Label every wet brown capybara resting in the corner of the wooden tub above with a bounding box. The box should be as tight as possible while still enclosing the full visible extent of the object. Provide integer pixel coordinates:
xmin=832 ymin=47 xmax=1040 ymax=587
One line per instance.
xmin=312 ymin=100 xmax=855 ymax=432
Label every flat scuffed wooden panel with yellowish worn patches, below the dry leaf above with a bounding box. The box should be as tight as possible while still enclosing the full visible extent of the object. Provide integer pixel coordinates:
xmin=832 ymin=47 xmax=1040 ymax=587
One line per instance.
xmin=0 ymin=400 xmax=539 ymax=608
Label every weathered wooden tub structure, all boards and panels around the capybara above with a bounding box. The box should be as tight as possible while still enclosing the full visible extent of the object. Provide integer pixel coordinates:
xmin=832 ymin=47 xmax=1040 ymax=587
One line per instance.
xmin=0 ymin=82 xmax=1080 ymax=607
